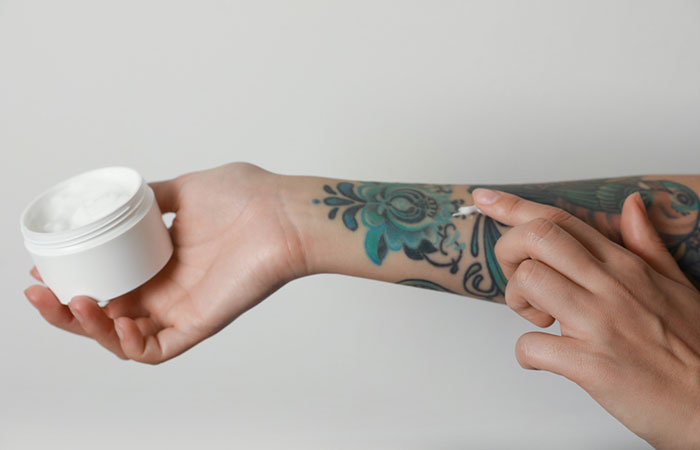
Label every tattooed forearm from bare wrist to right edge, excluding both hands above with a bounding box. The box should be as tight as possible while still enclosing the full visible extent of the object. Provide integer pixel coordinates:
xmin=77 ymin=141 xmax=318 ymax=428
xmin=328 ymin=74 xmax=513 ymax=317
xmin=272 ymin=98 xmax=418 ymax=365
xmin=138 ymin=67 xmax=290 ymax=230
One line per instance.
xmin=281 ymin=172 xmax=700 ymax=302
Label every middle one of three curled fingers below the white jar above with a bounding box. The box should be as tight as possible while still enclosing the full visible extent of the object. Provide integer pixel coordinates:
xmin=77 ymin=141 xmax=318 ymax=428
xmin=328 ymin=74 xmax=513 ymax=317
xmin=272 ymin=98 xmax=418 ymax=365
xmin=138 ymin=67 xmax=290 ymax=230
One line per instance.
xmin=68 ymin=296 xmax=126 ymax=359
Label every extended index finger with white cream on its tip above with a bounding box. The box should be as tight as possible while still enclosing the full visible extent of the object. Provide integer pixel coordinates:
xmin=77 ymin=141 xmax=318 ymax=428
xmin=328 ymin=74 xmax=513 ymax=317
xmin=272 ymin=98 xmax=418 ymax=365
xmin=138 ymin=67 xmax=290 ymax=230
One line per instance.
xmin=472 ymin=189 xmax=618 ymax=261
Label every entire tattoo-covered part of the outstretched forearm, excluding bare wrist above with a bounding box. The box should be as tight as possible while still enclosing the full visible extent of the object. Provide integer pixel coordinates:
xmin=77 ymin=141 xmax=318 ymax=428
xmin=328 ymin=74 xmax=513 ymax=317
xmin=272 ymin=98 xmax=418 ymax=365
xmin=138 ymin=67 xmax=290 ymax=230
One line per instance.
xmin=313 ymin=177 xmax=700 ymax=302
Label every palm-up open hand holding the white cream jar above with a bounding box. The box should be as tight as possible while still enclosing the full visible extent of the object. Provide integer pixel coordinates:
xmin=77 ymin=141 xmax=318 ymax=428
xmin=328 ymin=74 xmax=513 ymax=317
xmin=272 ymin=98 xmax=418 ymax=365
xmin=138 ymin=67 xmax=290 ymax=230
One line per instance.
xmin=25 ymin=163 xmax=308 ymax=364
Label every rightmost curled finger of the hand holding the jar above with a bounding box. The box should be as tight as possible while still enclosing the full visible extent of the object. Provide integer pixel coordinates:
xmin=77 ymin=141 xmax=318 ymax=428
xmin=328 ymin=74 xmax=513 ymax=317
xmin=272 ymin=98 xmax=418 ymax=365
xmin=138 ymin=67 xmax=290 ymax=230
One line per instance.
xmin=115 ymin=317 xmax=192 ymax=364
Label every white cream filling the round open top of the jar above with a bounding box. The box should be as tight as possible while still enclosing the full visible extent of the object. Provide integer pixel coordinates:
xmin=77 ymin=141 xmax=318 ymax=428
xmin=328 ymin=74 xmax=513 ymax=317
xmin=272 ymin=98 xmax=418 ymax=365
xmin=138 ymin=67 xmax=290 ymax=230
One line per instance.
xmin=30 ymin=167 xmax=138 ymax=233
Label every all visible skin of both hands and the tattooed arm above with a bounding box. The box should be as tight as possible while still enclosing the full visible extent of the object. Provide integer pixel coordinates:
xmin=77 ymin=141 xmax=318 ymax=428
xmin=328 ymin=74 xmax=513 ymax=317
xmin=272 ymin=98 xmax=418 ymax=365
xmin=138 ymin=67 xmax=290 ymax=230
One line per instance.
xmin=25 ymin=163 xmax=700 ymax=449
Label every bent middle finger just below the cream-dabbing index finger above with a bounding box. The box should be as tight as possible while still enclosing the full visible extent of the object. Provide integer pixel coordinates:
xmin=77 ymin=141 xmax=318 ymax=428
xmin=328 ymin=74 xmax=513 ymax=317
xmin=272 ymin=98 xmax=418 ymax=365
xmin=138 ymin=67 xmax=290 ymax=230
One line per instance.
xmin=495 ymin=214 xmax=605 ymax=286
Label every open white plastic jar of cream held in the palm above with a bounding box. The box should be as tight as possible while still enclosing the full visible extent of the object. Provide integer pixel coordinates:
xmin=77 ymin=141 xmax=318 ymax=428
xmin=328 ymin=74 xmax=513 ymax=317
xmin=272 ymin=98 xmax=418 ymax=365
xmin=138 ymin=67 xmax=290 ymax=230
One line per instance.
xmin=20 ymin=167 xmax=173 ymax=306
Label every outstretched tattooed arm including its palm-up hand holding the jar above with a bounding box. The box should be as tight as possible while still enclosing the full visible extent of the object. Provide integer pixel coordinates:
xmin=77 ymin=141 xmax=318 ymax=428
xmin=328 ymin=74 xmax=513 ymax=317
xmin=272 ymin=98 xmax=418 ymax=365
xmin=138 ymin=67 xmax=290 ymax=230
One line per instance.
xmin=25 ymin=163 xmax=700 ymax=364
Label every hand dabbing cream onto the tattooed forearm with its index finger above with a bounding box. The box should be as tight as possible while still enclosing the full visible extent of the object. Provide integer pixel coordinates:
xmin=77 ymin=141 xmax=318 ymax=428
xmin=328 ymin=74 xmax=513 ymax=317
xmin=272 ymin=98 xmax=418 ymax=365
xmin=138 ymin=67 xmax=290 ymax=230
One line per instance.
xmin=474 ymin=190 xmax=700 ymax=449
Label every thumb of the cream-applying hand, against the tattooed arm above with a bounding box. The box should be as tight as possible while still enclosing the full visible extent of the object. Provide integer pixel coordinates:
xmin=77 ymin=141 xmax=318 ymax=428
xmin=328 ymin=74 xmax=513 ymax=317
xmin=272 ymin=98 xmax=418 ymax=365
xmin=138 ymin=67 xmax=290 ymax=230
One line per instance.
xmin=620 ymin=192 xmax=693 ymax=287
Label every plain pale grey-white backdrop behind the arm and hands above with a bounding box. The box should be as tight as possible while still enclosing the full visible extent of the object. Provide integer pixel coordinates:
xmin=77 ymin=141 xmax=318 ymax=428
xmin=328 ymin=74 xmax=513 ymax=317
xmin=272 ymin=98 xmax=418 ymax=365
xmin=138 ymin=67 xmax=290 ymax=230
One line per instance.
xmin=0 ymin=0 xmax=700 ymax=450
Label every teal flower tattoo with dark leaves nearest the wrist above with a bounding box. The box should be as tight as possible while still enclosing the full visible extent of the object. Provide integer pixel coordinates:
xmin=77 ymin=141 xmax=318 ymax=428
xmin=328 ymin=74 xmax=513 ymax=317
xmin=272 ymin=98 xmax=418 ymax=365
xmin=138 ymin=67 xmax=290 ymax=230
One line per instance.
xmin=315 ymin=182 xmax=466 ymax=273
